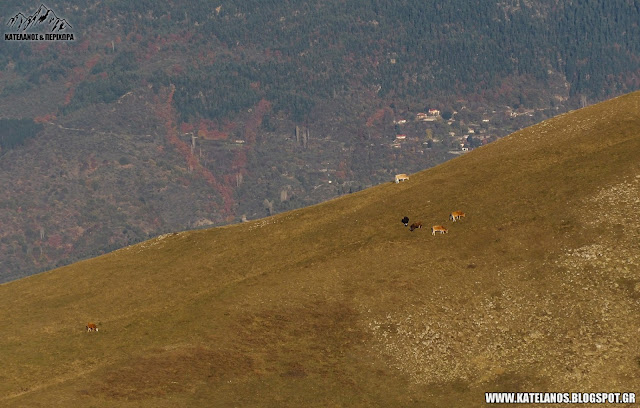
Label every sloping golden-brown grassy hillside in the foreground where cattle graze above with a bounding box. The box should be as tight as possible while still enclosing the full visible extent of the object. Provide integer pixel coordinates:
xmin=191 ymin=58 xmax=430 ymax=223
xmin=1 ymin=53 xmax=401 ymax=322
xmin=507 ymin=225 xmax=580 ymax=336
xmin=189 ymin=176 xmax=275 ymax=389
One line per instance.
xmin=0 ymin=93 xmax=640 ymax=407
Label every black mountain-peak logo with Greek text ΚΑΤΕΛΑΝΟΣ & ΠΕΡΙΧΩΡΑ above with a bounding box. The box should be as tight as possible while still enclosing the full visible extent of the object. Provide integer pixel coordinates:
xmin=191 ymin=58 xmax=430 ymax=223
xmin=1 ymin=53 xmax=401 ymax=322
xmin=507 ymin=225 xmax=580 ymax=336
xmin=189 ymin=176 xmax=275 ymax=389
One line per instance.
xmin=4 ymin=4 xmax=75 ymax=41
